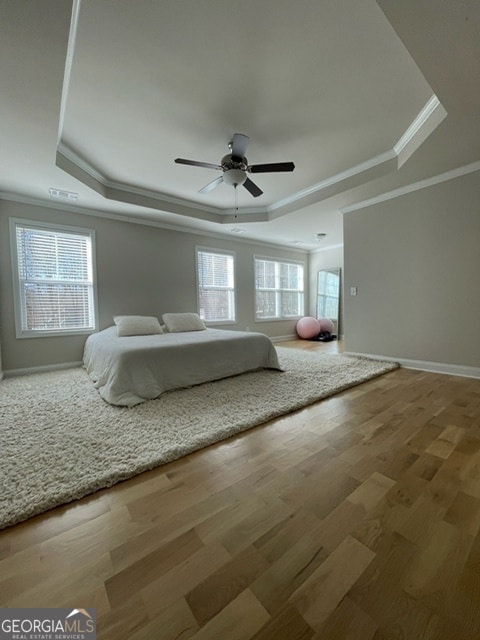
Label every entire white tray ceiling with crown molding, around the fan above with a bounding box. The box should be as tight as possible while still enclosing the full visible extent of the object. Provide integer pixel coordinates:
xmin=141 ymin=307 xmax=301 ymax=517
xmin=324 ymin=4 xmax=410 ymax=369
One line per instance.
xmin=0 ymin=0 xmax=480 ymax=250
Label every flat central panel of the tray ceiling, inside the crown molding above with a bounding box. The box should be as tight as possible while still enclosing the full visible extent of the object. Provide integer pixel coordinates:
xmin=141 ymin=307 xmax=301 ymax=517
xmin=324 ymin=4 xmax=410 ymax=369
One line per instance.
xmin=62 ymin=0 xmax=431 ymax=208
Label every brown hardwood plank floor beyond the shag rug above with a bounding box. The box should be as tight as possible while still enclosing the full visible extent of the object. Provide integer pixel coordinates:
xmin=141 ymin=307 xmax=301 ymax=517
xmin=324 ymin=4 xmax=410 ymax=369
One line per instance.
xmin=0 ymin=341 xmax=480 ymax=640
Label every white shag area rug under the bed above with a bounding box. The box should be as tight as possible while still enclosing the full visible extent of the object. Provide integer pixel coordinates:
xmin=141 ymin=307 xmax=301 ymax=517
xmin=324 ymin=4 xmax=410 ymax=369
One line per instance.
xmin=0 ymin=347 xmax=398 ymax=528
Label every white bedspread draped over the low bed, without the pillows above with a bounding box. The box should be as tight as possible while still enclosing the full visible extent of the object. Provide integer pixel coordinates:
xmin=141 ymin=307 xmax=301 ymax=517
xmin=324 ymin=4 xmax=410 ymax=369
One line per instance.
xmin=83 ymin=327 xmax=281 ymax=406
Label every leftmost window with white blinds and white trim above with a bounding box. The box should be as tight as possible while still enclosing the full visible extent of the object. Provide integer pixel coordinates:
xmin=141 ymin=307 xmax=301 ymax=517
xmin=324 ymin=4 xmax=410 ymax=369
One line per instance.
xmin=11 ymin=220 xmax=96 ymax=337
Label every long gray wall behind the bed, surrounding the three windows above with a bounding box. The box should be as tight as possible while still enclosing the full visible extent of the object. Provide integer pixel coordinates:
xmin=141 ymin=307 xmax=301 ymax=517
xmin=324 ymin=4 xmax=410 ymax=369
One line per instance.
xmin=0 ymin=201 xmax=308 ymax=372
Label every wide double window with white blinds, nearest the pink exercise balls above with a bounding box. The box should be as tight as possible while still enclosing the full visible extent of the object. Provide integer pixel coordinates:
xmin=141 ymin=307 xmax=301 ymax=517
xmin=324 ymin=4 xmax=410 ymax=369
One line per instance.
xmin=255 ymin=258 xmax=303 ymax=320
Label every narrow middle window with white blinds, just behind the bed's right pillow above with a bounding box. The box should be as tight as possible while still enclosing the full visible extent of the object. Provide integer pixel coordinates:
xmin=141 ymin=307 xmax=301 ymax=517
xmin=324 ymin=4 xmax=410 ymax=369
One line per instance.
xmin=197 ymin=249 xmax=235 ymax=322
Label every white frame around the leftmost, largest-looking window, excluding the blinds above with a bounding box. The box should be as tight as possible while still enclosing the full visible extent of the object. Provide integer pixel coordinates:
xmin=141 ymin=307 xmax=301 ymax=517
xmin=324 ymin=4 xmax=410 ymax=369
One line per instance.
xmin=9 ymin=218 xmax=98 ymax=338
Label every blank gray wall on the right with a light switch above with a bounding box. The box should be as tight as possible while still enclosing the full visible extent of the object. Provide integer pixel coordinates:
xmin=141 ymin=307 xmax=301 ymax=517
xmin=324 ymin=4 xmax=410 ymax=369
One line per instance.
xmin=344 ymin=172 xmax=480 ymax=367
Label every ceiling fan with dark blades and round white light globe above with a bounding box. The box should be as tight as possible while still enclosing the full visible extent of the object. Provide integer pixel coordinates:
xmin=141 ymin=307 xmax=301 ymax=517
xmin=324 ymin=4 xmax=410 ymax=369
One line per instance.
xmin=175 ymin=133 xmax=295 ymax=198
